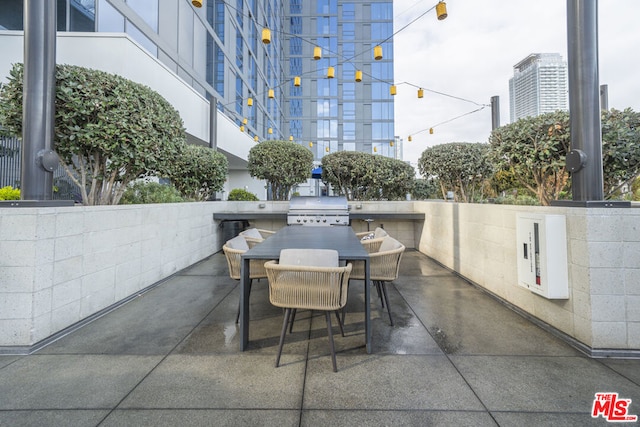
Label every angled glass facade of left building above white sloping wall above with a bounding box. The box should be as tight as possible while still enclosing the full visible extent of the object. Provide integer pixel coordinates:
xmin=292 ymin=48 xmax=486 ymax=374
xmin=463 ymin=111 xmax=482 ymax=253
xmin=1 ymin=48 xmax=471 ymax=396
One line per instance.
xmin=0 ymin=0 xmax=288 ymax=144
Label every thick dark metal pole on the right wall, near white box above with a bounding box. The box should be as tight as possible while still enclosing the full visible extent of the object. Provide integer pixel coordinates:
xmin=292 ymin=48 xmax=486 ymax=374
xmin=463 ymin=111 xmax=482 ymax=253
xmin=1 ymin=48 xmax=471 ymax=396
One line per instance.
xmin=567 ymin=0 xmax=604 ymax=202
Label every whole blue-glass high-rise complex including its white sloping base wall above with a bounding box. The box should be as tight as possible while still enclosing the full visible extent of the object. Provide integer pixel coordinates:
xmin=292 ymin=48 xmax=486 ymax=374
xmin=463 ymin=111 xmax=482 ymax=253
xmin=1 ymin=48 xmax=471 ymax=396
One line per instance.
xmin=0 ymin=0 xmax=398 ymax=198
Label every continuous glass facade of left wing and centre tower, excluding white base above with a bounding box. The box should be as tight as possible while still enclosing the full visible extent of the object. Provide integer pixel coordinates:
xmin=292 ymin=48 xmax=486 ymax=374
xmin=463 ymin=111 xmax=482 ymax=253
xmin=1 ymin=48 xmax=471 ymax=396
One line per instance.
xmin=0 ymin=0 xmax=394 ymax=160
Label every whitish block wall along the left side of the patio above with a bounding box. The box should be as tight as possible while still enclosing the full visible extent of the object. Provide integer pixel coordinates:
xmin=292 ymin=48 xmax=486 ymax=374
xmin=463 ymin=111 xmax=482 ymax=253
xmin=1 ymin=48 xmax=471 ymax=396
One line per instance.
xmin=0 ymin=203 xmax=219 ymax=347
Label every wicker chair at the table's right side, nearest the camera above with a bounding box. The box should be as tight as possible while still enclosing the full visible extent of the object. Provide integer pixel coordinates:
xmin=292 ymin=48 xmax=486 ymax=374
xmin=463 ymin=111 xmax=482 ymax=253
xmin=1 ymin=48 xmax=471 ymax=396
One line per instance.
xmin=350 ymin=236 xmax=405 ymax=326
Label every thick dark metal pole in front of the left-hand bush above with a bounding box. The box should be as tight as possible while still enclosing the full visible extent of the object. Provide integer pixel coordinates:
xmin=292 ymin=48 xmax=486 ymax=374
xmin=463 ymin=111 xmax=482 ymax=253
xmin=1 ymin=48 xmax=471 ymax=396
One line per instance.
xmin=20 ymin=0 xmax=57 ymax=200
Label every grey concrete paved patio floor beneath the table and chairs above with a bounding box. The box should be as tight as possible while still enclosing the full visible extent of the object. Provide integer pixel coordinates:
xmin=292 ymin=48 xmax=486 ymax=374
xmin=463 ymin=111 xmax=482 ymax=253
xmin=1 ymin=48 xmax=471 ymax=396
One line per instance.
xmin=0 ymin=251 xmax=640 ymax=427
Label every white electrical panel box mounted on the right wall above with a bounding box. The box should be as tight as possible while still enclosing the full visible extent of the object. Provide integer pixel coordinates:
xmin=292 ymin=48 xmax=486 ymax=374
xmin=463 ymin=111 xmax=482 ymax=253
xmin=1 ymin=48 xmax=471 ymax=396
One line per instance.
xmin=516 ymin=213 xmax=569 ymax=299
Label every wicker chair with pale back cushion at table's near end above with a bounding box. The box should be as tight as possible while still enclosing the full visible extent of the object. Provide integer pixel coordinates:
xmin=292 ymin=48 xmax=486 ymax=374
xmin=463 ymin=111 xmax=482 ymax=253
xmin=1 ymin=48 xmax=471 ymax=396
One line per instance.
xmin=264 ymin=249 xmax=351 ymax=372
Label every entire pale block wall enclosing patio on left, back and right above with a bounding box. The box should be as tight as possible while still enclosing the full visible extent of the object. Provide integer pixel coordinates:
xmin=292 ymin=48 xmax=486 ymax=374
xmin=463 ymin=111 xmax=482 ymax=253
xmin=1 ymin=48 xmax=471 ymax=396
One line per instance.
xmin=0 ymin=201 xmax=640 ymax=354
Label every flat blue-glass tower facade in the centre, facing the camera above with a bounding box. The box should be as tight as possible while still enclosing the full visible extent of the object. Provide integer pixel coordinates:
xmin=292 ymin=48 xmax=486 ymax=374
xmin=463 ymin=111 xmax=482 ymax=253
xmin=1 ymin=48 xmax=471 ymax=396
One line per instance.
xmin=284 ymin=0 xmax=394 ymax=160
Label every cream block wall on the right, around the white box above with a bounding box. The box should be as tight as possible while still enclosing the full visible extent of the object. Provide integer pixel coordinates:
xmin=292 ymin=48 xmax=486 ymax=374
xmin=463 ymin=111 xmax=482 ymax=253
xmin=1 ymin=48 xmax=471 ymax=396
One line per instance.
xmin=415 ymin=201 xmax=640 ymax=354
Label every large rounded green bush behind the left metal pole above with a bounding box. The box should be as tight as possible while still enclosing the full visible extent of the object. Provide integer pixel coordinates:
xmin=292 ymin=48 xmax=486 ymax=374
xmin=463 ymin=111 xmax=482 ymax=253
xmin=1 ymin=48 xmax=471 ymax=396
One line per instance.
xmin=0 ymin=64 xmax=186 ymax=205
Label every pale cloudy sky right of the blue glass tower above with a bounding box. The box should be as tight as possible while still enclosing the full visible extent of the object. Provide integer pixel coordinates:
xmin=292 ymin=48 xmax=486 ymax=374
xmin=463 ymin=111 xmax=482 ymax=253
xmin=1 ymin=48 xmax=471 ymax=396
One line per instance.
xmin=393 ymin=0 xmax=640 ymax=167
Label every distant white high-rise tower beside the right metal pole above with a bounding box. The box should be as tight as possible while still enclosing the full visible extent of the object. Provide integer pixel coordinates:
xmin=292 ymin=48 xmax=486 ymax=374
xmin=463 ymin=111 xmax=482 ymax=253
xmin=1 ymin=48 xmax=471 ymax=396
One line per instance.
xmin=509 ymin=53 xmax=569 ymax=122
